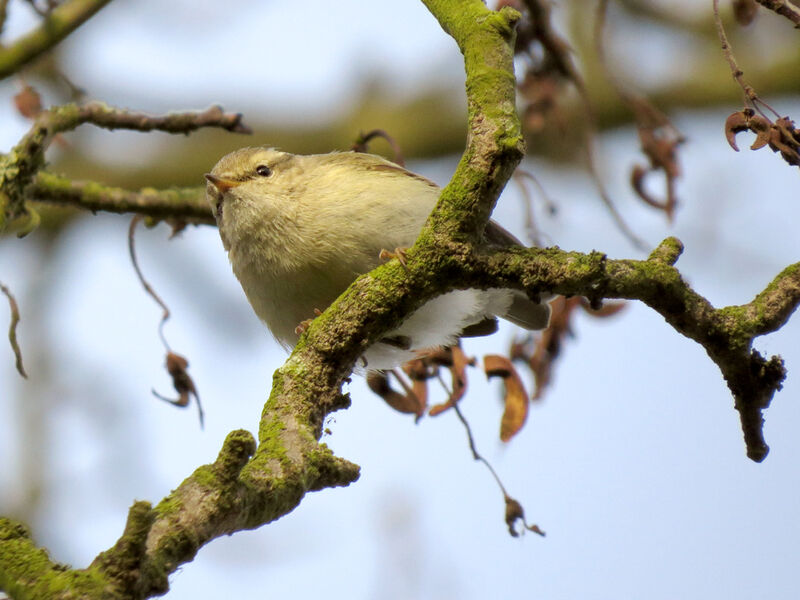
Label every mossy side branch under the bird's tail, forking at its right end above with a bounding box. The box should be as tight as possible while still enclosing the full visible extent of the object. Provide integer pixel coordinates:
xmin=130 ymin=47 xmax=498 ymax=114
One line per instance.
xmin=466 ymin=238 xmax=800 ymax=462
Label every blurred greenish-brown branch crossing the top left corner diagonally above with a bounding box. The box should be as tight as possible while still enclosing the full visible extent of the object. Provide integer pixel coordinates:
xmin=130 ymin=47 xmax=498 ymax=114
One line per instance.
xmin=0 ymin=0 xmax=110 ymax=80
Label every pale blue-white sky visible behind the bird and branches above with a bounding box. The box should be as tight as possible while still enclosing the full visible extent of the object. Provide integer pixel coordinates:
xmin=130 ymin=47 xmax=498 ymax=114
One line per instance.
xmin=0 ymin=0 xmax=800 ymax=600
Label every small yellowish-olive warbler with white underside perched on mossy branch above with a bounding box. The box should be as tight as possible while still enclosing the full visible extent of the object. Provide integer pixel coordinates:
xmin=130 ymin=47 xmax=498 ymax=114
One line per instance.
xmin=205 ymin=148 xmax=550 ymax=369
